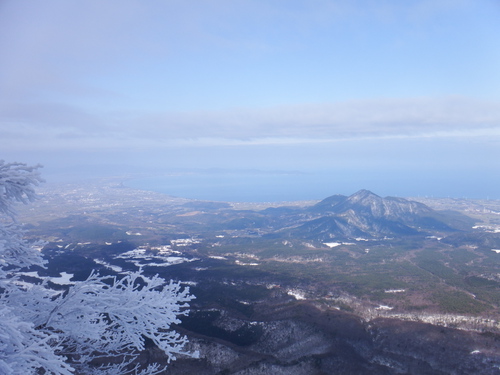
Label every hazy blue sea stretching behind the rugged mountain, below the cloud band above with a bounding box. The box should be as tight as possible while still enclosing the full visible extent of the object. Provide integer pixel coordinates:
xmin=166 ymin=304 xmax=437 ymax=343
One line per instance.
xmin=126 ymin=169 xmax=500 ymax=202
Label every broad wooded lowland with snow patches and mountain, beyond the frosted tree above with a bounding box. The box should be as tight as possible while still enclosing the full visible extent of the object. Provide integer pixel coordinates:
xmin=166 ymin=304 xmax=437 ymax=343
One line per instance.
xmin=18 ymin=180 xmax=500 ymax=375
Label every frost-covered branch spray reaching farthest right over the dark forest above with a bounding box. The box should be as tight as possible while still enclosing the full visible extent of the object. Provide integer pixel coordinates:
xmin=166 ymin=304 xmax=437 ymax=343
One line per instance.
xmin=44 ymin=273 xmax=193 ymax=360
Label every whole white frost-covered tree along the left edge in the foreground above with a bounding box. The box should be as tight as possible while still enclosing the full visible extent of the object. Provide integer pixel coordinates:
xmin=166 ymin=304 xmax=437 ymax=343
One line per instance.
xmin=0 ymin=160 xmax=195 ymax=375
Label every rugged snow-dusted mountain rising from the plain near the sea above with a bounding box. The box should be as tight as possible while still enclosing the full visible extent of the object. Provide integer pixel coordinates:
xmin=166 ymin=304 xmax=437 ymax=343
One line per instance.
xmin=291 ymin=190 xmax=472 ymax=240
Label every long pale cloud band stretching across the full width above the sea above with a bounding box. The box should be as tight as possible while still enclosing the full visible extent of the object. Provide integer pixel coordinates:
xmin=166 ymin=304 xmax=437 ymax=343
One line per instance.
xmin=0 ymin=97 xmax=500 ymax=149
